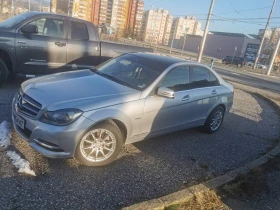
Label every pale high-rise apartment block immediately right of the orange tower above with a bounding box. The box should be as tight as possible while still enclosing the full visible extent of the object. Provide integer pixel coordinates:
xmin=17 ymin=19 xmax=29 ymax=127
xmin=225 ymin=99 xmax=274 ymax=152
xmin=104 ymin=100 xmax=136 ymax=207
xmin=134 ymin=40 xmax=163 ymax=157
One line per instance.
xmin=142 ymin=9 xmax=172 ymax=44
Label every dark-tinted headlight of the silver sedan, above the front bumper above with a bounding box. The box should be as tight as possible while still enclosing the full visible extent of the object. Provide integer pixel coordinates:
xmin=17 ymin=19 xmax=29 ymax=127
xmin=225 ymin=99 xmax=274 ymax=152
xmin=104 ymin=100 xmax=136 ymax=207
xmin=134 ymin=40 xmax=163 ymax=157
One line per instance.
xmin=39 ymin=109 xmax=83 ymax=126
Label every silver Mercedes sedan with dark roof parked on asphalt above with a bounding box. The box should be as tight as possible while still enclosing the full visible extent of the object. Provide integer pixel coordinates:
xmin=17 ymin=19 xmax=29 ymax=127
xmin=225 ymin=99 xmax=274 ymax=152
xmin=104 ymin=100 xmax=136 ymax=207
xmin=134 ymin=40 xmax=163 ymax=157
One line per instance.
xmin=12 ymin=53 xmax=233 ymax=166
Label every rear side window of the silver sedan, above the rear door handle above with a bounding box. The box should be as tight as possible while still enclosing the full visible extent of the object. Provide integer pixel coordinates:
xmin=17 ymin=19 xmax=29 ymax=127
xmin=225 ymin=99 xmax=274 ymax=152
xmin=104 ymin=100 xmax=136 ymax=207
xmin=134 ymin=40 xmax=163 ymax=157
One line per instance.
xmin=190 ymin=66 xmax=220 ymax=89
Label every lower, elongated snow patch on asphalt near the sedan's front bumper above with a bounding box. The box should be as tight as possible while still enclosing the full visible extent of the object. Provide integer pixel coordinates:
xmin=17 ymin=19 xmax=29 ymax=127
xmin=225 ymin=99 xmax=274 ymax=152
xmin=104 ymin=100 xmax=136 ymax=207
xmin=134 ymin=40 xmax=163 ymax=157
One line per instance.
xmin=7 ymin=151 xmax=36 ymax=176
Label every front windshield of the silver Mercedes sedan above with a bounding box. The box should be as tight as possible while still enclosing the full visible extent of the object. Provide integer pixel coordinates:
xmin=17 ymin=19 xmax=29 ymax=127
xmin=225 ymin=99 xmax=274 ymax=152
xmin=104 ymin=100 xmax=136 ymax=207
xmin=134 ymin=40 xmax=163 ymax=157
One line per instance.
xmin=95 ymin=54 xmax=162 ymax=90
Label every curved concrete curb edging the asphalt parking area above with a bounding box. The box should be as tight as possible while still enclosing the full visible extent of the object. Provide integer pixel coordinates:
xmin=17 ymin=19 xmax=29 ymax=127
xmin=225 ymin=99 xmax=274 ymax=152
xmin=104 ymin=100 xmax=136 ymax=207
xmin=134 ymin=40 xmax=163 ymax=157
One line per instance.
xmin=123 ymin=93 xmax=280 ymax=210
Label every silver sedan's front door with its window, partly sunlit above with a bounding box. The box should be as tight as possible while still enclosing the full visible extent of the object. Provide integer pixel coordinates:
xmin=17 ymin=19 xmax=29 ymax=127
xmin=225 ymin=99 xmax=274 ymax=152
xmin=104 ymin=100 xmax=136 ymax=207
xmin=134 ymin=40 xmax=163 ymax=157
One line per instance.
xmin=141 ymin=66 xmax=198 ymax=135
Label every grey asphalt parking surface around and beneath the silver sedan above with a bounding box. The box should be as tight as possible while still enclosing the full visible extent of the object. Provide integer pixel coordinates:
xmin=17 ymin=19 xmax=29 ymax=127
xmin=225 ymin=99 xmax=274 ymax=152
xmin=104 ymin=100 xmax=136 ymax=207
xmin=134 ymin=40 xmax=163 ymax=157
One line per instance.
xmin=0 ymin=79 xmax=280 ymax=209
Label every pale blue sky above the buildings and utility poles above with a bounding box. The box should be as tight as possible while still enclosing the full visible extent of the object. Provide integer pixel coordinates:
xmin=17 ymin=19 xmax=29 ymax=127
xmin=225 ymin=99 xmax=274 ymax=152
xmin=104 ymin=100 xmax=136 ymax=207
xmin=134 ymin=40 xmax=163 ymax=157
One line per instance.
xmin=144 ymin=0 xmax=280 ymax=34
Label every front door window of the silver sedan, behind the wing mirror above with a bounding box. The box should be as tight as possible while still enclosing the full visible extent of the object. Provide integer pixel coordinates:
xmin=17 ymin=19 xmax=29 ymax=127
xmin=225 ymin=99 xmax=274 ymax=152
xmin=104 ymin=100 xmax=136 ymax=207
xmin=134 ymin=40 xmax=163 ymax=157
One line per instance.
xmin=160 ymin=66 xmax=190 ymax=92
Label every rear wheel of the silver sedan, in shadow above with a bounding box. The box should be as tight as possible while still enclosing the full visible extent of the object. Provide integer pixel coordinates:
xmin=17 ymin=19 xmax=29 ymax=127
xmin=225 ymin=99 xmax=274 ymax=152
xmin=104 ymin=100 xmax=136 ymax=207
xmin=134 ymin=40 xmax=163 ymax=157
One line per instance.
xmin=203 ymin=106 xmax=225 ymax=134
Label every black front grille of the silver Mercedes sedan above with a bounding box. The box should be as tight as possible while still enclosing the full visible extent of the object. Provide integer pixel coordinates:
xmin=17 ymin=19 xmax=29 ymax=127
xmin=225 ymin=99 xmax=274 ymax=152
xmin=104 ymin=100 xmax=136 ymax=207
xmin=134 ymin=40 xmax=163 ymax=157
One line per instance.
xmin=16 ymin=93 xmax=42 ymax=118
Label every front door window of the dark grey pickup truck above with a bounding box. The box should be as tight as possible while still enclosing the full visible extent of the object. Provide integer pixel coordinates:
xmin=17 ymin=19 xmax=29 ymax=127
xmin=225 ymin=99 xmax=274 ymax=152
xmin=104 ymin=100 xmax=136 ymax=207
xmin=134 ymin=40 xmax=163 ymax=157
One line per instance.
xmin=23 ymin=18 xmax=64 ymax=38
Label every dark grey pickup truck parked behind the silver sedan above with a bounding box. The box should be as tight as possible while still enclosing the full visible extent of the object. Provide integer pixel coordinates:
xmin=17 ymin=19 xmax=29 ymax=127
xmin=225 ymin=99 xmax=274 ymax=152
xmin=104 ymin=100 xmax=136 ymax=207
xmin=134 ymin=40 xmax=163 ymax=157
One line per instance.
xmin=0 ymin=12 xmax=153 ymax=85
